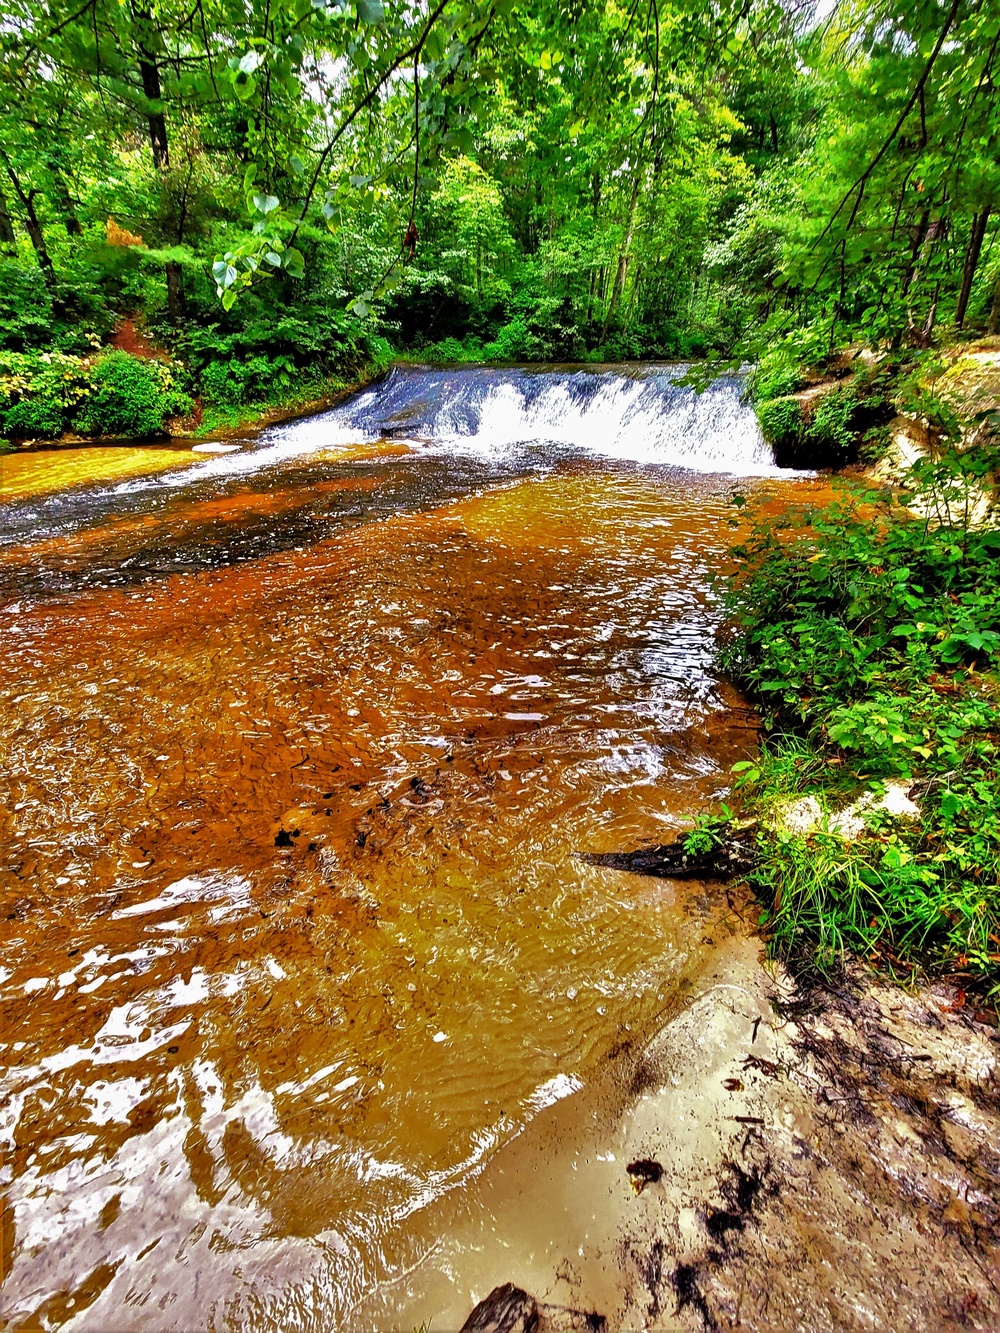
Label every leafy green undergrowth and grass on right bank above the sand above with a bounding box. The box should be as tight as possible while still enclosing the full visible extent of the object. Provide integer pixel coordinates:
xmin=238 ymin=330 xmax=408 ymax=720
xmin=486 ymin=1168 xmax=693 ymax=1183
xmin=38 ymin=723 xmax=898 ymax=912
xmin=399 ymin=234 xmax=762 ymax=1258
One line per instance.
xmin=723 ymin=449 xmax=1000 ymax=996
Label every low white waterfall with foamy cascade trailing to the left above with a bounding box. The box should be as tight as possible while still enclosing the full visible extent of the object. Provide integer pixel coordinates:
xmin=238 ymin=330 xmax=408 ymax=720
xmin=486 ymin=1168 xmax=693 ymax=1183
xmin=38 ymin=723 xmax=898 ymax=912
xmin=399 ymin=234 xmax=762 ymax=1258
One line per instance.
xmin=0 ymin=365 xmax=793 ymax=548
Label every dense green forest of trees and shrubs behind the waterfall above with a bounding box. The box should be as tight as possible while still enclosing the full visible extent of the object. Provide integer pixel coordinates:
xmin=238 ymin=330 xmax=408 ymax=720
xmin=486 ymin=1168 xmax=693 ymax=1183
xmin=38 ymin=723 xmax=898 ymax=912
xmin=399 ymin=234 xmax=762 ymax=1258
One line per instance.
xmin=0 ymin=0 xmax=1000 ymax=439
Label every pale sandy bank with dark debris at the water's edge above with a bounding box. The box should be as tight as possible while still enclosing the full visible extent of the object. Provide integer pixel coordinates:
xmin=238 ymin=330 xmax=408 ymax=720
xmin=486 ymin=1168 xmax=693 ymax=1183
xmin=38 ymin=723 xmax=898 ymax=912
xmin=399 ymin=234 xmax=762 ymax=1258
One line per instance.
xmin=435 ymin=901 xmax=1000 ymax=1333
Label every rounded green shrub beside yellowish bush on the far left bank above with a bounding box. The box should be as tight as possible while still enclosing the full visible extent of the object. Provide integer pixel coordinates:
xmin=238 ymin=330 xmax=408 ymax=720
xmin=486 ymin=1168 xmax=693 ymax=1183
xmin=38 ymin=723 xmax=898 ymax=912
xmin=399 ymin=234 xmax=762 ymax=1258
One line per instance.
xmin=77 ymin=352 xmax=191 ymax=437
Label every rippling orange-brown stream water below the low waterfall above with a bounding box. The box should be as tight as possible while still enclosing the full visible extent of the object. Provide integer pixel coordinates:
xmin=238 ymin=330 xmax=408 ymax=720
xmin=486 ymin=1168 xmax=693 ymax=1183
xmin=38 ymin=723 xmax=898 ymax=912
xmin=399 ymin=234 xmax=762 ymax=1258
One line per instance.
xmin=0 ymin=372 xmax=808 ymax=1330
